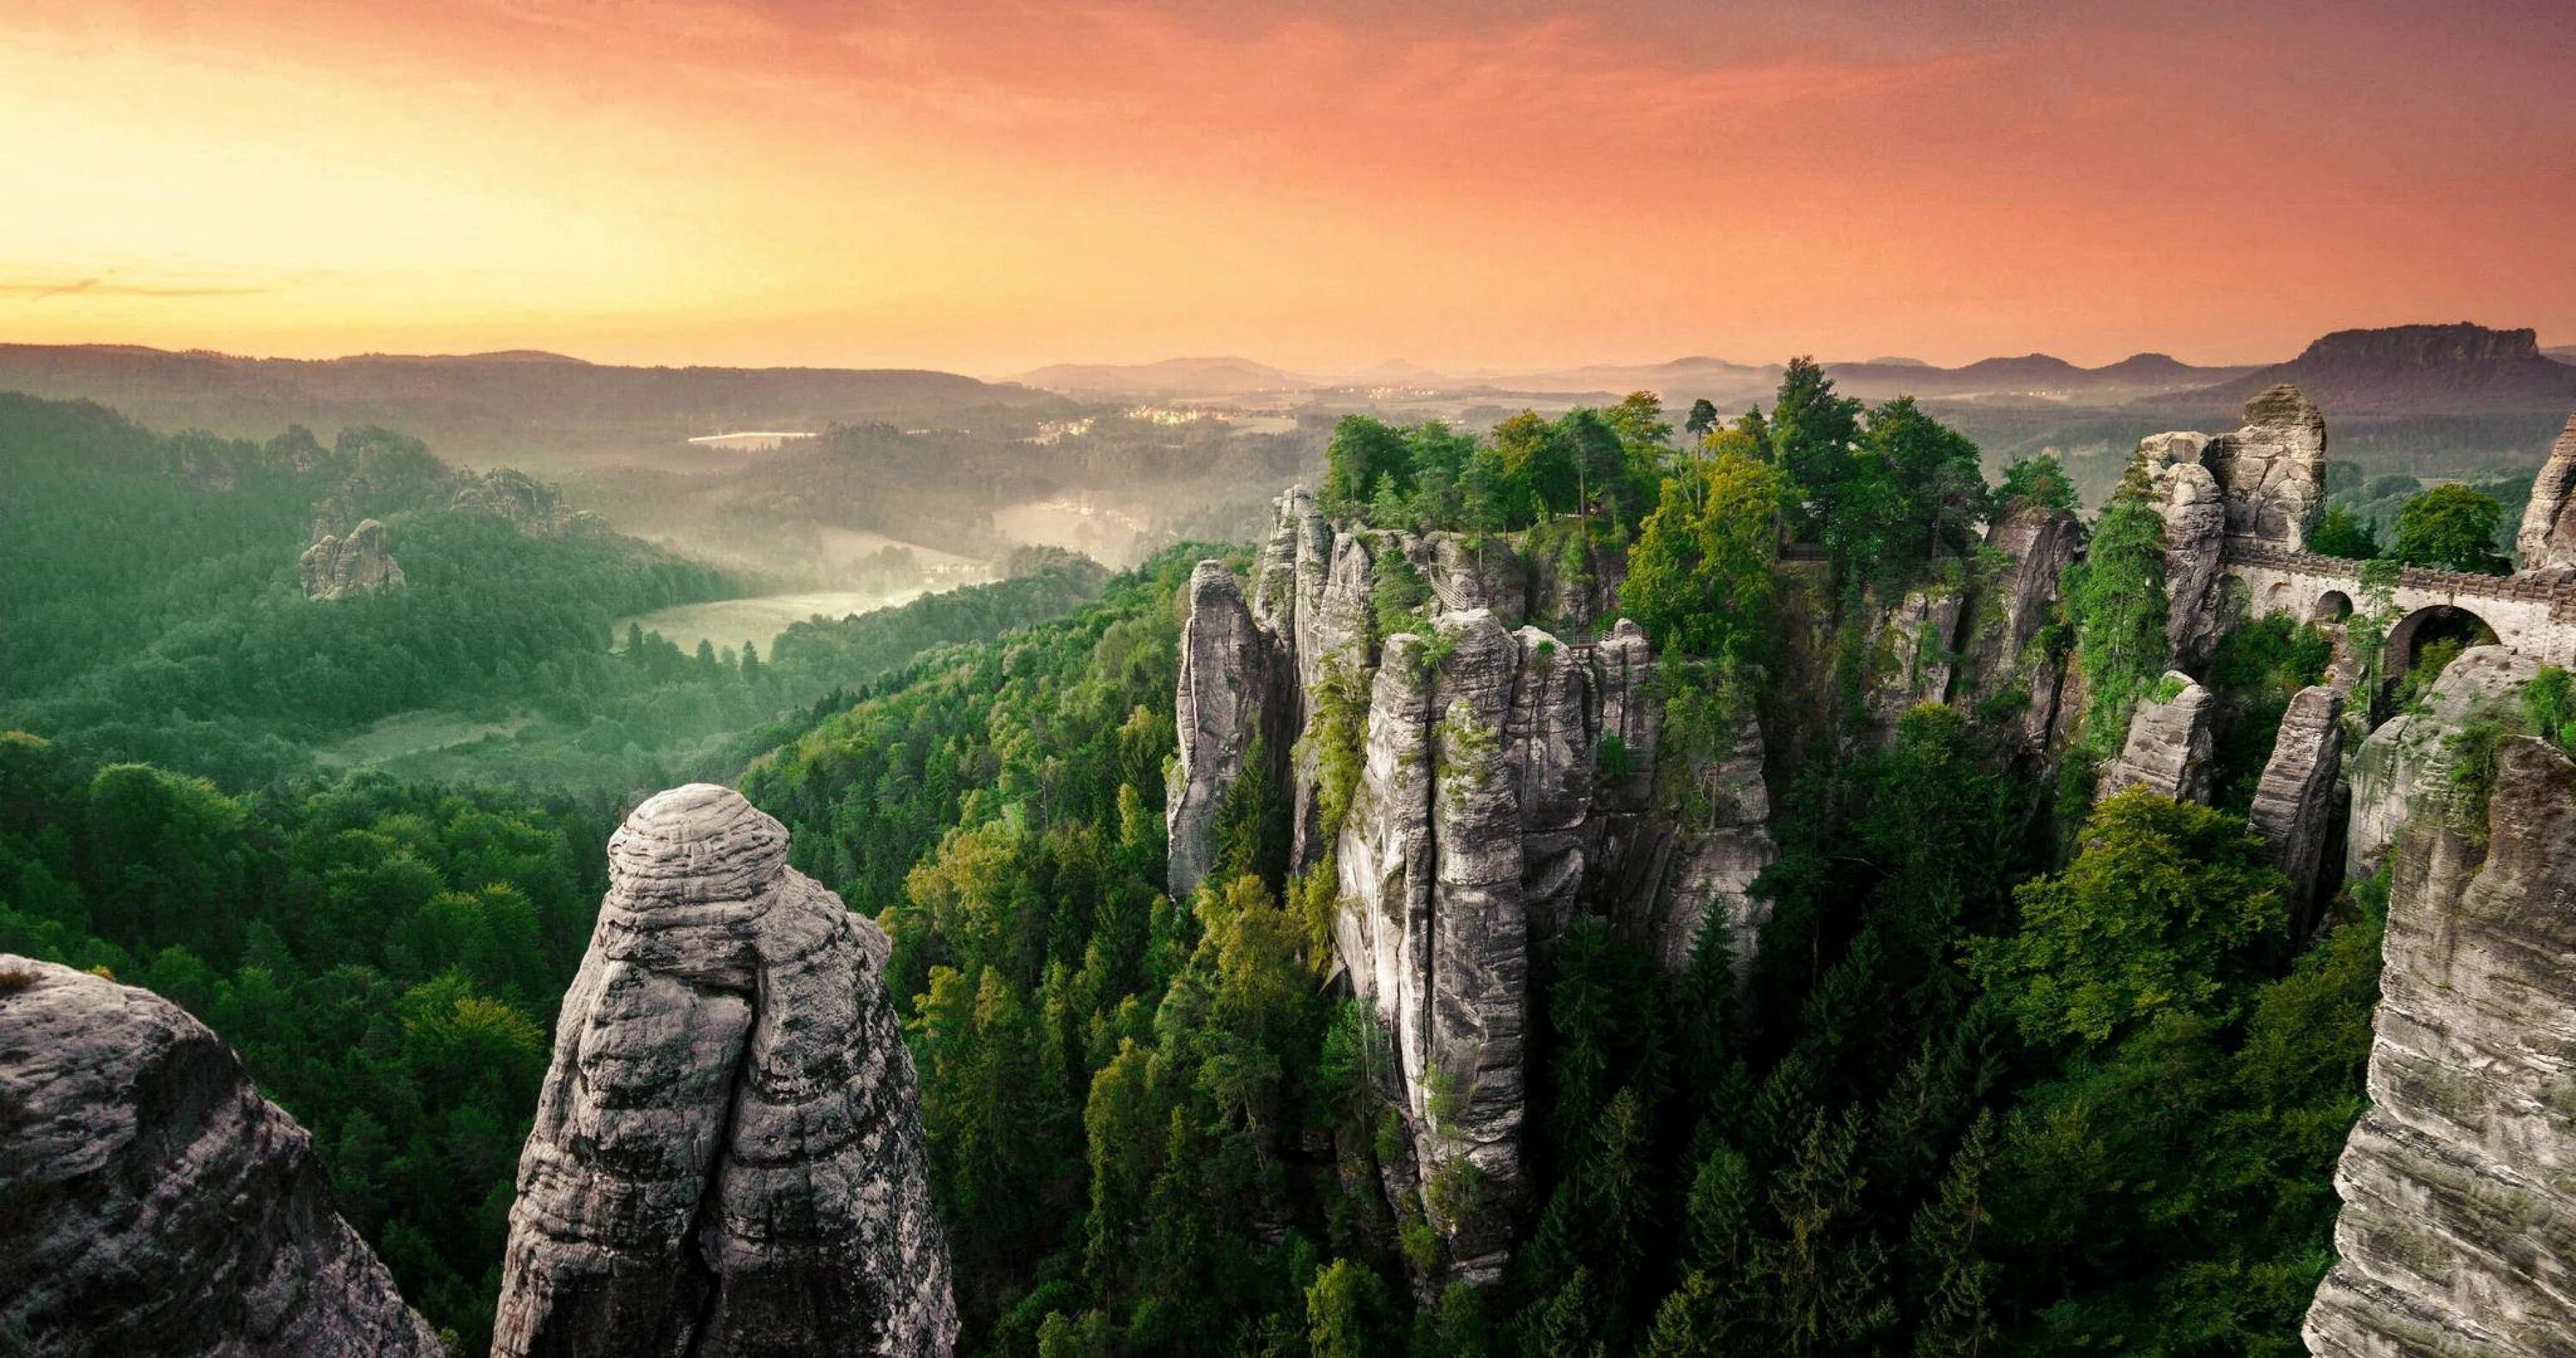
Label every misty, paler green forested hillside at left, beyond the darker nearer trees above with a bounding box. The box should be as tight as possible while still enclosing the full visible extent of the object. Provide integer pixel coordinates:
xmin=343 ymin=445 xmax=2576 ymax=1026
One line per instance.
xmin=0 ymin=394 xmax=1105 ymax=794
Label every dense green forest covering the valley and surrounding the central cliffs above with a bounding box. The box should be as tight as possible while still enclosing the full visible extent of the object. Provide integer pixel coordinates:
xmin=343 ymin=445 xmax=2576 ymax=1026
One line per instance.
xmin=0 ymin=363 xmax=2473 ymax=1358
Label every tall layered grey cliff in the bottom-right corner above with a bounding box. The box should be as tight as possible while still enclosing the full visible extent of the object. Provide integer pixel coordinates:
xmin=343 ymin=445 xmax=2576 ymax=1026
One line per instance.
xmin=2303 ymin=737 xmax=2576 ymax=1358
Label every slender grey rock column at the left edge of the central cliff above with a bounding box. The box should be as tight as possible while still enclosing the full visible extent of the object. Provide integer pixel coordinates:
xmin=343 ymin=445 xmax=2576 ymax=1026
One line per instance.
xmin=1164 ymin=561 xmax=1283 ymax=894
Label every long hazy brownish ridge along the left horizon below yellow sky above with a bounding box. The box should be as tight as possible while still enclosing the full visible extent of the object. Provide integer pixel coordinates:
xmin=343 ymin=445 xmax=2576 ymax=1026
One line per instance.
xmin=0 ymin=345 xmax=1064 ymax=461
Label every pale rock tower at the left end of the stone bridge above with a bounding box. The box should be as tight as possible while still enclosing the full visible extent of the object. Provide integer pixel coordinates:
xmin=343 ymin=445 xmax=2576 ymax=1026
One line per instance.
xmin=2138 ymin=386 xmax=2326 ymax=670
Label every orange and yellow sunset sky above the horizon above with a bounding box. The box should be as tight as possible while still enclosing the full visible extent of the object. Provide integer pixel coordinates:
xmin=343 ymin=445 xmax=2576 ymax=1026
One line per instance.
xmin=0 ymin=0 xmax=2576 ymax=373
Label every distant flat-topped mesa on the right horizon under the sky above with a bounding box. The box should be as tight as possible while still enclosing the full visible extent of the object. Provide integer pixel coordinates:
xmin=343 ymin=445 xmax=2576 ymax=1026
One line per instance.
xmin=2172 ymin=322 xmax=2576 ymax=415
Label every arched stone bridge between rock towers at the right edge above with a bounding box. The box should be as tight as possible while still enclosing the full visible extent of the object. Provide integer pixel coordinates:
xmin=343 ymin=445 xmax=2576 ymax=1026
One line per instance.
xmin=2221 ymin=538 xmax=2576 ymax=670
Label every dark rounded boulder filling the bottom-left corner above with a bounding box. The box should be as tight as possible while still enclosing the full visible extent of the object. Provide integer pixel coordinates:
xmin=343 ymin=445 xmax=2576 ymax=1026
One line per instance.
xmin=0 ymin=956 xmax=443 ymax=1358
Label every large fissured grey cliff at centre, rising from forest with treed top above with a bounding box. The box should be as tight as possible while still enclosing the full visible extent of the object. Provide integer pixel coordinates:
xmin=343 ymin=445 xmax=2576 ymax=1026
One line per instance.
xmin=1167 ymin=492 xmax=1772 ymax=1283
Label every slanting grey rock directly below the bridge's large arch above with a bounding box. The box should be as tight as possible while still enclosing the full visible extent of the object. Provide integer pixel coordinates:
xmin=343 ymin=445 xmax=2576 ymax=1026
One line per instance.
xmin=2344 ymin=646 xmax=2540 ymax=882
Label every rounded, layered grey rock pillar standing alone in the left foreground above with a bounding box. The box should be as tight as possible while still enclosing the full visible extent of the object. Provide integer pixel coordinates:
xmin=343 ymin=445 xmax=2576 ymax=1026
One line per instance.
xmin=492 ymin=784 xmax=958 ymax=1358
